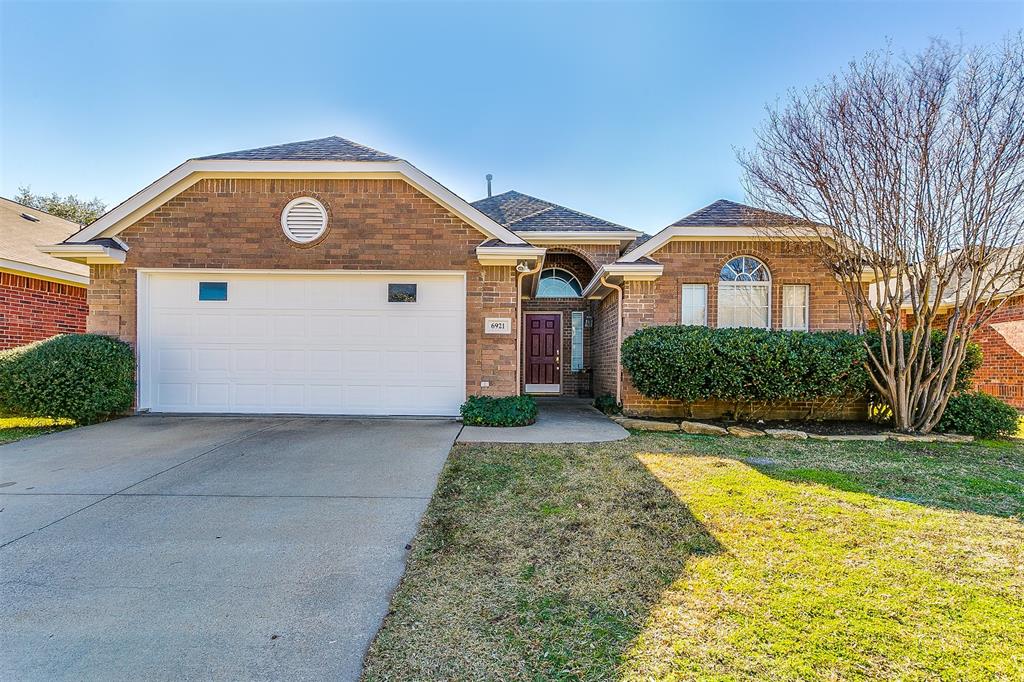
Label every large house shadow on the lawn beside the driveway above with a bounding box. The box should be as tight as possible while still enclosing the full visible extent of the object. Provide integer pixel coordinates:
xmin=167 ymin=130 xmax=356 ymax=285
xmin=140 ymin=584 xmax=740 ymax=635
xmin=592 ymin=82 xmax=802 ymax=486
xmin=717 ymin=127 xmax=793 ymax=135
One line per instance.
xmin=367 ymin=444 xmax=722 ymax=680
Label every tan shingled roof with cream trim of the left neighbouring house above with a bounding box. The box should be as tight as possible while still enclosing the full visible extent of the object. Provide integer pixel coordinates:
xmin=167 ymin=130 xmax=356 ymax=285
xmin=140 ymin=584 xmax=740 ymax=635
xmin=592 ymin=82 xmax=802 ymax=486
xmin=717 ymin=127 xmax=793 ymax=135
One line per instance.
xmin=0 ymin=197 xmax=89 ymax=286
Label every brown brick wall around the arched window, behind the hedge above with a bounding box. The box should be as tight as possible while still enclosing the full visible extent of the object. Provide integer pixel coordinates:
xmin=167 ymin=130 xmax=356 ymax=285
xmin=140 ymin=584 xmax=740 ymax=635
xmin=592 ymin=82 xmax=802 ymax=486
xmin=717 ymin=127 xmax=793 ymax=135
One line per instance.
xmin=612 ymin=241 xmax=866 ymax=419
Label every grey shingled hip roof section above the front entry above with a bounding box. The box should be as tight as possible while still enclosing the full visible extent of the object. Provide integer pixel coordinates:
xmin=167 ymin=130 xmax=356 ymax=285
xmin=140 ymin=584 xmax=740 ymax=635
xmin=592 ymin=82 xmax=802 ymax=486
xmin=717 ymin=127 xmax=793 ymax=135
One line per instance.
xmin=472 ymin=191 xmax=634 ymax=232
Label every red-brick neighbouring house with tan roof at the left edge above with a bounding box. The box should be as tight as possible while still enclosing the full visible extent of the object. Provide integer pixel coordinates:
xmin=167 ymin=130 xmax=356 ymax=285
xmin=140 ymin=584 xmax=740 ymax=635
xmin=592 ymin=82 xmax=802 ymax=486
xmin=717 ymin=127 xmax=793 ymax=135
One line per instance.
xmin=0 ymin=197 xmax=89 ymax=350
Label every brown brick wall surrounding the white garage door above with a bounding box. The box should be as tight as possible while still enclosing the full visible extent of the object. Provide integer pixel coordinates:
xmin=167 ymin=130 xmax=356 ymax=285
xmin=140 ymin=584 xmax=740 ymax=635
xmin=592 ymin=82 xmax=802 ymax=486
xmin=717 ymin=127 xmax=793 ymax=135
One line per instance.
xmin=88 ymin=179 xmax=516 ymax=395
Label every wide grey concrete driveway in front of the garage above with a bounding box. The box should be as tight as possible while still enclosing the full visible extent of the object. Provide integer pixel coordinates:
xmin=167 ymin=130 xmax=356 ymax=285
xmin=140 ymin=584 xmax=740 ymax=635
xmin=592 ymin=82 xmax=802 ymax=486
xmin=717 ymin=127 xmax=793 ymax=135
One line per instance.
xmin=0 ymin=417 xmax=459 ymax=680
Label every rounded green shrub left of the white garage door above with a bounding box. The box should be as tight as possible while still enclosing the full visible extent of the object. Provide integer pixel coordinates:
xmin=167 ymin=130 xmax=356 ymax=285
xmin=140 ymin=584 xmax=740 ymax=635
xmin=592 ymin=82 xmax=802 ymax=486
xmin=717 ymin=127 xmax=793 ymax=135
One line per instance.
xmin=0 ymin=334 xmax=135 ymax=424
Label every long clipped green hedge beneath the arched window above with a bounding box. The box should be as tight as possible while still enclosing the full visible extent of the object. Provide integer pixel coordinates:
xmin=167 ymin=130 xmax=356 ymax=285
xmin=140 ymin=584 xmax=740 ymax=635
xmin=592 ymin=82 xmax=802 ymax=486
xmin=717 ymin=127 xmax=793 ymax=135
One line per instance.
xmin=623 ymin=327 xmax=866 ymax=402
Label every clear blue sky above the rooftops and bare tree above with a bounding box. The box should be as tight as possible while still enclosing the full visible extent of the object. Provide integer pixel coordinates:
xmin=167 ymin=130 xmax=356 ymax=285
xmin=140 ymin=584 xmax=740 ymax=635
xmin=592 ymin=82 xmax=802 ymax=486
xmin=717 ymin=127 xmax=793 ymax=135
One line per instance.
xmin=0 ymin=0 xmax=1024 ymax=231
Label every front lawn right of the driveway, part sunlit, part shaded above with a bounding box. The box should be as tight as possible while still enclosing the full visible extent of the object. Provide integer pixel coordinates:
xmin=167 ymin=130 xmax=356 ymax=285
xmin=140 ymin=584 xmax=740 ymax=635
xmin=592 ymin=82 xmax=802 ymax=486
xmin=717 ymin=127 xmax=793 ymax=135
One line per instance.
xmin=365 ymin=434 xmax=1024 ymax=681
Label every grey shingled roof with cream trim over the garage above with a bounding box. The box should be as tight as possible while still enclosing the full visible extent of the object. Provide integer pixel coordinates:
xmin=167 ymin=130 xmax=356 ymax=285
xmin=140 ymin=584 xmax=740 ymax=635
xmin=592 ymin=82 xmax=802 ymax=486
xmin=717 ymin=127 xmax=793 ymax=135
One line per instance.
xmin=60 ymin=137 xmax=526 ymax=246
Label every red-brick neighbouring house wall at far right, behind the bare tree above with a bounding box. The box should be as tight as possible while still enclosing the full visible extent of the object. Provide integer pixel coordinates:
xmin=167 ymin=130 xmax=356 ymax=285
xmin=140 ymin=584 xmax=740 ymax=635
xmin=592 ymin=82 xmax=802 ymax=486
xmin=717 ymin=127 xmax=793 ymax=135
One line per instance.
xmin=934 ymin=296 xmax=1024 ymax=410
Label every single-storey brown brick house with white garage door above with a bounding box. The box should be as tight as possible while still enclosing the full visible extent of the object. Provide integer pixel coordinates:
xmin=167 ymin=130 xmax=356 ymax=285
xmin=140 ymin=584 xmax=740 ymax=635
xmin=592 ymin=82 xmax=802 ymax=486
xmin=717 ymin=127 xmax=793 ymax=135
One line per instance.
xmin=43 ymin=137 xmax=852 ymax=415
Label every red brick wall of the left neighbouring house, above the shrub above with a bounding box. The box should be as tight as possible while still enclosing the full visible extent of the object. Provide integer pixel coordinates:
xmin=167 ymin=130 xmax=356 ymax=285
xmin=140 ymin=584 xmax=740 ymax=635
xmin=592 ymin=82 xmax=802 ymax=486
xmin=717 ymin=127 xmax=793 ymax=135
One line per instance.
xmin=0 ymin=272 xmax=89 ymax=350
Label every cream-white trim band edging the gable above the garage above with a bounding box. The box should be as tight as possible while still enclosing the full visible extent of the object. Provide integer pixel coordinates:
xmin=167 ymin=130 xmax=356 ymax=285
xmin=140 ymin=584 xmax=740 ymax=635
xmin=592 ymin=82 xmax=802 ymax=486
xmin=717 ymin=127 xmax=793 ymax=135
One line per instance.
xmin=68 ymin=159 xmax=525 ymax=244
